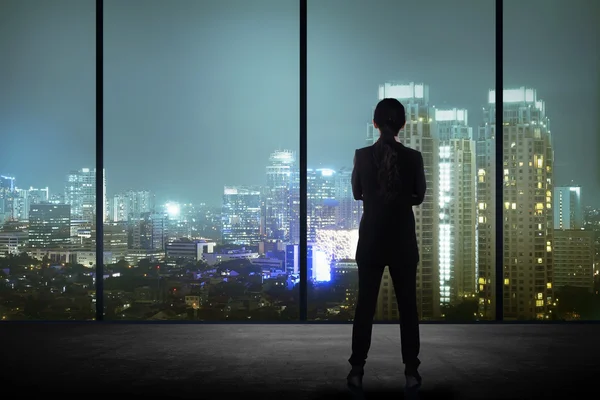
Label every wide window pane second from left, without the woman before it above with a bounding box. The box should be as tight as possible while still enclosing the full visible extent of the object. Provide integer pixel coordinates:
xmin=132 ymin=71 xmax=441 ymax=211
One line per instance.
xmin=104 ymin=0 xmax=299 ymax=321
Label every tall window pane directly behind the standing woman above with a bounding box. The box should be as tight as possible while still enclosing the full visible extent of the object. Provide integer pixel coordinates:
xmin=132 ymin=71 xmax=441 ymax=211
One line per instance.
xmin=308 ymin=0 xmax=495 ymax=321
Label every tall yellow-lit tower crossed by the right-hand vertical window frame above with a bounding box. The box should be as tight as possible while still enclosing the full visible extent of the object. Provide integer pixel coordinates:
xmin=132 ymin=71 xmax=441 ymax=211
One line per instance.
xmin=477 ymin=87 xmax=554 ymax=320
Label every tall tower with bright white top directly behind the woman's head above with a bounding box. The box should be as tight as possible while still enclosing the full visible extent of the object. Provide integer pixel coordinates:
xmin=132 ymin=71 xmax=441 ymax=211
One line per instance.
xmin=367 ymin=82 xmax=440 ymax=320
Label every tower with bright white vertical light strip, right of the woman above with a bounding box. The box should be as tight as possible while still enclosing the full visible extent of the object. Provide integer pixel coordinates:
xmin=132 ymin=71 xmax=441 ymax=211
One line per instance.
xmin=432 ymin=108 xmax=477 ymax=305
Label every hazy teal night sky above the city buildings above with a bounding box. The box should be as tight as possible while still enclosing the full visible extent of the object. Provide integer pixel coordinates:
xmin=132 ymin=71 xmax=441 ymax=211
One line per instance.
xmin=0 ymin=0 xmax=600 ymax=206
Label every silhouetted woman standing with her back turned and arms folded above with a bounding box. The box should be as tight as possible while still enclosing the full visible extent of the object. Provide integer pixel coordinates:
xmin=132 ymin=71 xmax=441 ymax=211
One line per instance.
xmin=348 ymin=99 xmax=426 ymax=396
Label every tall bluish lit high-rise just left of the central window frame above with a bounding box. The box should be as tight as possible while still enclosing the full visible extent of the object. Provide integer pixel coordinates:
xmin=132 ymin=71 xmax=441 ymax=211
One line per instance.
xmin=265 ymin=150 xmax=296 ymax=241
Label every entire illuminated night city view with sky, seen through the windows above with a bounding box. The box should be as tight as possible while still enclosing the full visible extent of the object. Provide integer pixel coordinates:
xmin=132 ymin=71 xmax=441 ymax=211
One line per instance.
xmin=0 ymin=0 xmax=600 ymax=321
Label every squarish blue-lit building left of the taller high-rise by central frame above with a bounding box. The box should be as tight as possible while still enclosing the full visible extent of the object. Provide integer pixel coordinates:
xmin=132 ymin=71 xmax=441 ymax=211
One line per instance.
xmin=221 ymin=186 xmax=261 ymax=246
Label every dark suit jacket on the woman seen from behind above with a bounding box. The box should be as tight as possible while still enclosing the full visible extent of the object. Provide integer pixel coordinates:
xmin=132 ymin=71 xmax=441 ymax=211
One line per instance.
xmin=352 ymin=142 xmax=426 ymax=265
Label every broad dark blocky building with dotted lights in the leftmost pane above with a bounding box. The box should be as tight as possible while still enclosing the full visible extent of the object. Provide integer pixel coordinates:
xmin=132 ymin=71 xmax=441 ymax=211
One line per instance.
xmin=29 ymin=204 xmax=71 ymax=249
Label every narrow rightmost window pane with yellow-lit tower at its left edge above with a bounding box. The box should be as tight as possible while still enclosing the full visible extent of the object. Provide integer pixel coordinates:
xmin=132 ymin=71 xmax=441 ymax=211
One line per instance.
xmin=503 ymin=0 xmax=600 ymax=320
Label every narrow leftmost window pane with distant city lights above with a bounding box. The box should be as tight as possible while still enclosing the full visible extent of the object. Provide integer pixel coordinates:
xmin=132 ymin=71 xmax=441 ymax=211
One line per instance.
xmin=0 ymin=0 xmax=96 ymax=320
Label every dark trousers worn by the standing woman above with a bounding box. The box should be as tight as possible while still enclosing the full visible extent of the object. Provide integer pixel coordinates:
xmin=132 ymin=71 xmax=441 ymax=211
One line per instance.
xmin=348 ymin=262 xmax=421 ymax=374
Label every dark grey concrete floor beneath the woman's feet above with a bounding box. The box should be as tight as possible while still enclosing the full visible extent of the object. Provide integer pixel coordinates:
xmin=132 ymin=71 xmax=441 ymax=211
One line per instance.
xmin=0 ymin=323 xmax=600 ymax=400
